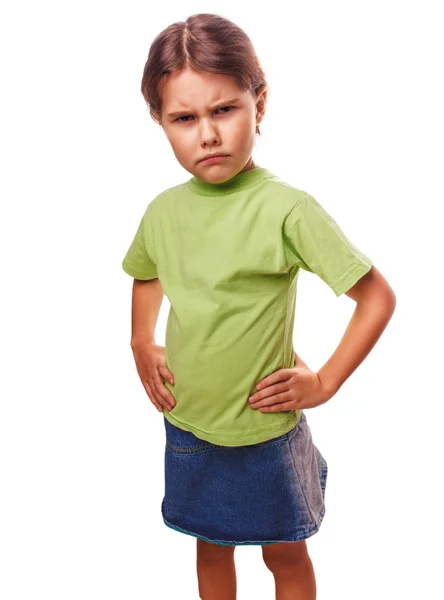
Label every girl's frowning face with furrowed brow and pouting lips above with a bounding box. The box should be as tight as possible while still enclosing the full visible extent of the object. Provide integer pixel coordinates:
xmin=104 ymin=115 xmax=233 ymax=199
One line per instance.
xmin=161 ymin=67 xmax=266 ymax=183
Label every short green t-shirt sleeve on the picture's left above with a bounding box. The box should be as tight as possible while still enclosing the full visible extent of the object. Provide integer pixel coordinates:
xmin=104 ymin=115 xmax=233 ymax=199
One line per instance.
xmin=122 ymin=206 xmax=158 ymax=280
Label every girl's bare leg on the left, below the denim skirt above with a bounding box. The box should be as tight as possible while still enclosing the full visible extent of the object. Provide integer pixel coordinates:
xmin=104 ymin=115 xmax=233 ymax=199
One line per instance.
xmin=196 ymin=538 xmax=236 ymax=600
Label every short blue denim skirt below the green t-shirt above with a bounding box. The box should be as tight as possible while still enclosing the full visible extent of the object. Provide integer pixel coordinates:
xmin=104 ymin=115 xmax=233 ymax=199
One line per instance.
xmin=161 ymin=411 xmax=327 ymax=546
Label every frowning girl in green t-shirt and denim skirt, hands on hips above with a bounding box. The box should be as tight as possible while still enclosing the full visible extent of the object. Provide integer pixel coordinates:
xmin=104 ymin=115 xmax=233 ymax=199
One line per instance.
xmin=122 ymin=14 xmax=396 ymax=600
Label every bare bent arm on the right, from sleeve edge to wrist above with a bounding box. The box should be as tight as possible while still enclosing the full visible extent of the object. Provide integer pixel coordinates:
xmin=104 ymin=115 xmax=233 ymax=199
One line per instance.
xmin=318 ymin=266 xmax=396 ymax=395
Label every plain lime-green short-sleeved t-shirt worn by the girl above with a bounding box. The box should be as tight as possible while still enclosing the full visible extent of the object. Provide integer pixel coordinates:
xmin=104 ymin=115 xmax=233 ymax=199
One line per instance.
xmin=122 ymin=167 xmax=372 ymax=446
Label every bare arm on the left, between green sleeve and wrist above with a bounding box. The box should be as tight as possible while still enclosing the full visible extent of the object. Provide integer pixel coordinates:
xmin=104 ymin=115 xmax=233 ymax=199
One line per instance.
xmin=131 ymin=279 xmax=164 ymax=348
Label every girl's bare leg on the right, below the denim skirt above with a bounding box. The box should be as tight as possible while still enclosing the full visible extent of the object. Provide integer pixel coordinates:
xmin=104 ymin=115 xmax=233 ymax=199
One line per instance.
xmin=262 ymin=540 xmax=316 ymax=600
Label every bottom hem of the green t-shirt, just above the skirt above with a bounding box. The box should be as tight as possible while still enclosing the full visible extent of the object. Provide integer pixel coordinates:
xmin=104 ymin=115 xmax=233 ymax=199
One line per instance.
xmin=163 ymin=409 xmax=302 ymax=446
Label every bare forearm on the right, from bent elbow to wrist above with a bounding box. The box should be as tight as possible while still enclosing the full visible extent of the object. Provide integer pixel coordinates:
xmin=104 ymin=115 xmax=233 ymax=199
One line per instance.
xmin=318 ymin=301 xmax=395 ymax=395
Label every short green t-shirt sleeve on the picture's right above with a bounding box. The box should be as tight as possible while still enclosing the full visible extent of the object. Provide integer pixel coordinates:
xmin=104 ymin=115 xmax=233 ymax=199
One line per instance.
xmin=283 ymin=192 xmax=373 ymax=296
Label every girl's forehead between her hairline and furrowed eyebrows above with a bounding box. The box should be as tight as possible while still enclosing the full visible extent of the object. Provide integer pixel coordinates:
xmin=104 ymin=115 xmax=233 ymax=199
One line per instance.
xmin=160 ymin=68 xmax=248 ymax=113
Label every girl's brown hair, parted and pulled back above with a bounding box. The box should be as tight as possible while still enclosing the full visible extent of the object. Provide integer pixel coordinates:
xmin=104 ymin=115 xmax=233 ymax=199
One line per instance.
xmin=141 ymin=13 xmax=268 ymax=135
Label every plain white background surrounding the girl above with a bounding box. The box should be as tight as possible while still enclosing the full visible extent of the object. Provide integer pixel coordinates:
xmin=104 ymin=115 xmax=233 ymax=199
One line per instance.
xmin=0 ymin=0 xmax=444 ymax=600
